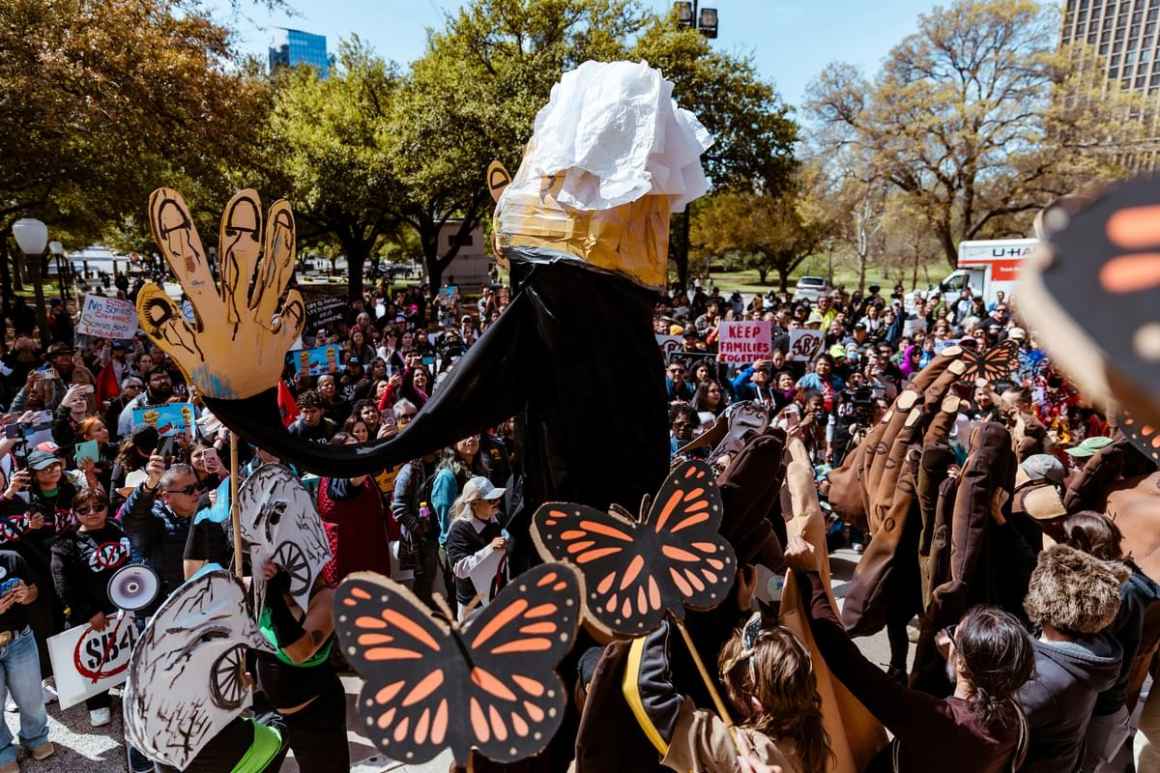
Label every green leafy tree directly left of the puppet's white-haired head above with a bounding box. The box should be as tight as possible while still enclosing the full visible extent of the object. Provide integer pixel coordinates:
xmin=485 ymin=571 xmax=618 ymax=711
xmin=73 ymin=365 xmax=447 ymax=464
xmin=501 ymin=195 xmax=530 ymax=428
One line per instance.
xmin=392 ymin=0 xmax=643 ymax=289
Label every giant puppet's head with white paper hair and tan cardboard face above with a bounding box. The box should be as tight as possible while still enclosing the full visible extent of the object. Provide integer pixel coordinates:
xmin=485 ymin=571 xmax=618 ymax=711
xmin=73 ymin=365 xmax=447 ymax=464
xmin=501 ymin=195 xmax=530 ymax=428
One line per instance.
xmin=488 ymin=62 xmax=713 ymax=288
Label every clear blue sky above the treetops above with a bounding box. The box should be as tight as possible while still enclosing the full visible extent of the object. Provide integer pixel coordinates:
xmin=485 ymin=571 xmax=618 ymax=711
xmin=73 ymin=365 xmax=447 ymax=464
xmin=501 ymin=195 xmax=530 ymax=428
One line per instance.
xmin=205 ymin=0 xmax=947 ymax=104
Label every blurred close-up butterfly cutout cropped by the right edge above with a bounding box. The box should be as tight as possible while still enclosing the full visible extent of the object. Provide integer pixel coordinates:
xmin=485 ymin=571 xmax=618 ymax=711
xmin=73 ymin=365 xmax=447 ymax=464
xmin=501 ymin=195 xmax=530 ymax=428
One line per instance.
xmin=1017 ymin=175 xmax=1160 ymax=426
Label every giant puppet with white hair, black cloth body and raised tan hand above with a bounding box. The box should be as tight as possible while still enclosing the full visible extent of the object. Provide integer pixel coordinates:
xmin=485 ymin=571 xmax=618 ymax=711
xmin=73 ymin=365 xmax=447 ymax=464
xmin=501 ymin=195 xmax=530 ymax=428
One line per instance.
xmin=137 ymin=62 xmax=712 ymax=559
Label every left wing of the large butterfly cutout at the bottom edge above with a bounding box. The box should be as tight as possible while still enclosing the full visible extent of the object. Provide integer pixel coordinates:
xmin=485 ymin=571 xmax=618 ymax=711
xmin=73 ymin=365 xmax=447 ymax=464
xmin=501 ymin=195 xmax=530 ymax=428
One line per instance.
xmin=334 ymin=572 xmax=471 ymax=765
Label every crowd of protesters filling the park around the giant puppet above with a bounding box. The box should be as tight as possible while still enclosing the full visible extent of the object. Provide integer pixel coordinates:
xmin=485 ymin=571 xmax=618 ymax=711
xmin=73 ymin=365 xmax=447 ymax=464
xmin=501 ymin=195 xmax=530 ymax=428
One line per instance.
xmin=0 ymin=266 xmax=1160 ymax=773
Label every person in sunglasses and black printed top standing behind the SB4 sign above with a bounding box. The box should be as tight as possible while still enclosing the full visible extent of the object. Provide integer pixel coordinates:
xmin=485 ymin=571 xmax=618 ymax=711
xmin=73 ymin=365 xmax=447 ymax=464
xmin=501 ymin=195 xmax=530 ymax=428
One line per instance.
xmin=52 ymin=489 xmax=132 ymax=728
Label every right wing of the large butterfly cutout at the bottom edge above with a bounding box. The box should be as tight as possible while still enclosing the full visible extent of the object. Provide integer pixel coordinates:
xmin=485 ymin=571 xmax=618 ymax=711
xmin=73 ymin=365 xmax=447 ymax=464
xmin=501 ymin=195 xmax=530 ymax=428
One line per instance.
xmin=456 ymin=563 xmax=582 ymax=763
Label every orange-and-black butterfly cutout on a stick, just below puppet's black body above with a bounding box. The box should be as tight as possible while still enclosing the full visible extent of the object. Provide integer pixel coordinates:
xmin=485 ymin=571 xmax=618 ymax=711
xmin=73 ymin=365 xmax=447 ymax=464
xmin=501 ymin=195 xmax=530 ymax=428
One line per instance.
xmin=531 ymin=461 xmax=737 ymax=636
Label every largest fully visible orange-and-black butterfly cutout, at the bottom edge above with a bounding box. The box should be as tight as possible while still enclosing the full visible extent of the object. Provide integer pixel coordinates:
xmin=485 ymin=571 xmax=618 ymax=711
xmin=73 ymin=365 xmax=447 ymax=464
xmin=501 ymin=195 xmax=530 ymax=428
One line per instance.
xmin=334 ymin=564 xmax=583 ymax=765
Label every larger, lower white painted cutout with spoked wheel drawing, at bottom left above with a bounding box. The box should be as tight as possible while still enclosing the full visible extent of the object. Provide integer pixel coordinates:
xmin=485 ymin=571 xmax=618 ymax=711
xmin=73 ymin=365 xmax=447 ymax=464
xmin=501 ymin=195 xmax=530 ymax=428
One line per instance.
xmin=123 ymin=569 xmax=273 ymax=770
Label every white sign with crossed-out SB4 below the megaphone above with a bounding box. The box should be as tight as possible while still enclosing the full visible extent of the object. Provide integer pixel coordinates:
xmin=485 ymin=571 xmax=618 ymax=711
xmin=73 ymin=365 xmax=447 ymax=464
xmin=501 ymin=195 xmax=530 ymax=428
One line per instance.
xmin=48 ymin=612 xmax=137 ymax=709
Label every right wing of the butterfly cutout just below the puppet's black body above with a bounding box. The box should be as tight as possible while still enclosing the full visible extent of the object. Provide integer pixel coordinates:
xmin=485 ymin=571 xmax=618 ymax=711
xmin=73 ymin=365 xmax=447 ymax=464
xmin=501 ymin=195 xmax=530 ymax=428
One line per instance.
xmin=641 ymin=461 xmax=737 ymax=617
